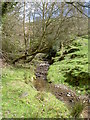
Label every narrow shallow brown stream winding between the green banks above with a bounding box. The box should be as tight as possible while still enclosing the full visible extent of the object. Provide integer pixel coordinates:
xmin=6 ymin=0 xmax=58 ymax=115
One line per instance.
xmin=34 ymin=61 xmax=88 ymax=118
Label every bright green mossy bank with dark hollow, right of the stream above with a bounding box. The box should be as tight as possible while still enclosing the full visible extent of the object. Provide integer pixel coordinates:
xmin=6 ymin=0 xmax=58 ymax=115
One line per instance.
xmin=48 ymin=37 xmax=90 ymax=94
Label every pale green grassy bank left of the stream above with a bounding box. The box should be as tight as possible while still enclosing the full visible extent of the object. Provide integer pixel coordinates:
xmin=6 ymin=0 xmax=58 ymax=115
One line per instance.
xmin=2 ymin=66 xmax=70 ymax=118
